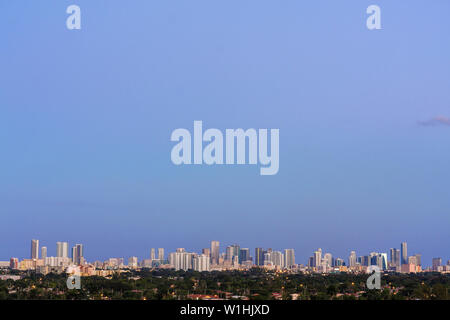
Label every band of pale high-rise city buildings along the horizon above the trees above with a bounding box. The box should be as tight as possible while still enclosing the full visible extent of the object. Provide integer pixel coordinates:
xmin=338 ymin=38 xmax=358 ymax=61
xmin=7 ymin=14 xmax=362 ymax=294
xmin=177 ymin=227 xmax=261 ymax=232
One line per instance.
xmin=5 ymin=239 xmax=450 ymax=274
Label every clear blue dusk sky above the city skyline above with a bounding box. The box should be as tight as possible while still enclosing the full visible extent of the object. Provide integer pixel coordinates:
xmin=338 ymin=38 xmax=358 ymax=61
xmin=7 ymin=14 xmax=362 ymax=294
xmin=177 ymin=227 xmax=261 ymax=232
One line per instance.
xmin=0 ymin=0 xmax=450 ymax=265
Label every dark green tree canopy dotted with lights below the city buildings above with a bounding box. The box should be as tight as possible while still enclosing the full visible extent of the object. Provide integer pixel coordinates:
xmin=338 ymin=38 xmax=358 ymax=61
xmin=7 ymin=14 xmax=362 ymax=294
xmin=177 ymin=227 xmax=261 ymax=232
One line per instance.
xmin=0 ymin=269 xmax=450 ymax=300
